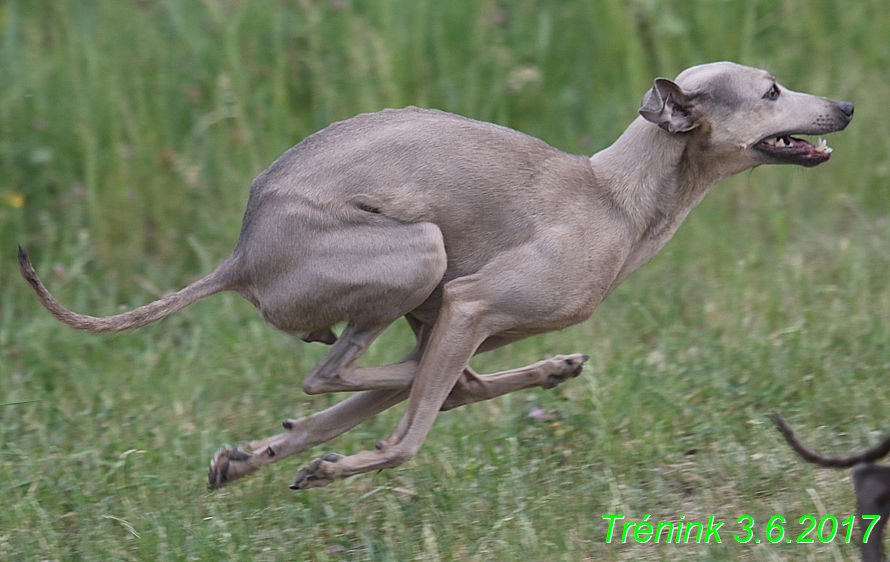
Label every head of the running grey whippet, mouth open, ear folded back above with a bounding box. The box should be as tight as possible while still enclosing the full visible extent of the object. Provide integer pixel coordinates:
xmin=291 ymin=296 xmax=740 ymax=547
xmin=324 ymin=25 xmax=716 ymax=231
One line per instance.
xmin=640 ymin=62 xmax=853 ymax=171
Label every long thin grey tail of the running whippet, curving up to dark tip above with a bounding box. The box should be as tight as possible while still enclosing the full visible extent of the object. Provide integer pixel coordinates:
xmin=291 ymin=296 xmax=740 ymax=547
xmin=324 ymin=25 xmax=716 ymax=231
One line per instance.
xmin=19 ymin=246 xmax=237 ymax=332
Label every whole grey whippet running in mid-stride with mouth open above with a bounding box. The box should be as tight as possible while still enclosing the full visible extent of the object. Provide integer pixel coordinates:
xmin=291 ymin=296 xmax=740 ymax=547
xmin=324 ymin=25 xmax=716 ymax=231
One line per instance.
xmin=20 ymin=62 xmax=853 ymax=489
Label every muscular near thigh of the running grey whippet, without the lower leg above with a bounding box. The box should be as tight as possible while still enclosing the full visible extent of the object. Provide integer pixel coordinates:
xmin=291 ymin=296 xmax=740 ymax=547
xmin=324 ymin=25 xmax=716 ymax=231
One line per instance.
xmin=248 ymin=219 xmax=448 ymax=336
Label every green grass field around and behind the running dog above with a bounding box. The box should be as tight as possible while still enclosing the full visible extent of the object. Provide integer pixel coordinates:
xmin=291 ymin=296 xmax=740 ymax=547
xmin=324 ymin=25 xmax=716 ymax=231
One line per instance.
xmin=0 ymin=0 xmax=890 ymax=561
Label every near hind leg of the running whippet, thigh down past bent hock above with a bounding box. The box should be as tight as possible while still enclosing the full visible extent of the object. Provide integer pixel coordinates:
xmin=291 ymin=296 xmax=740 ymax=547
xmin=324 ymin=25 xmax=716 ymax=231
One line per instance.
xmin=256 ymin=217 xmax=447 ymax=394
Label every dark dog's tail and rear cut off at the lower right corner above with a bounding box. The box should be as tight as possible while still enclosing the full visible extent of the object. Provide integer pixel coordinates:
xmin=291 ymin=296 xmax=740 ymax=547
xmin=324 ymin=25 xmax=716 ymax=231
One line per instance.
xmin=772 ymin=414 xmax=890 ymax=562
